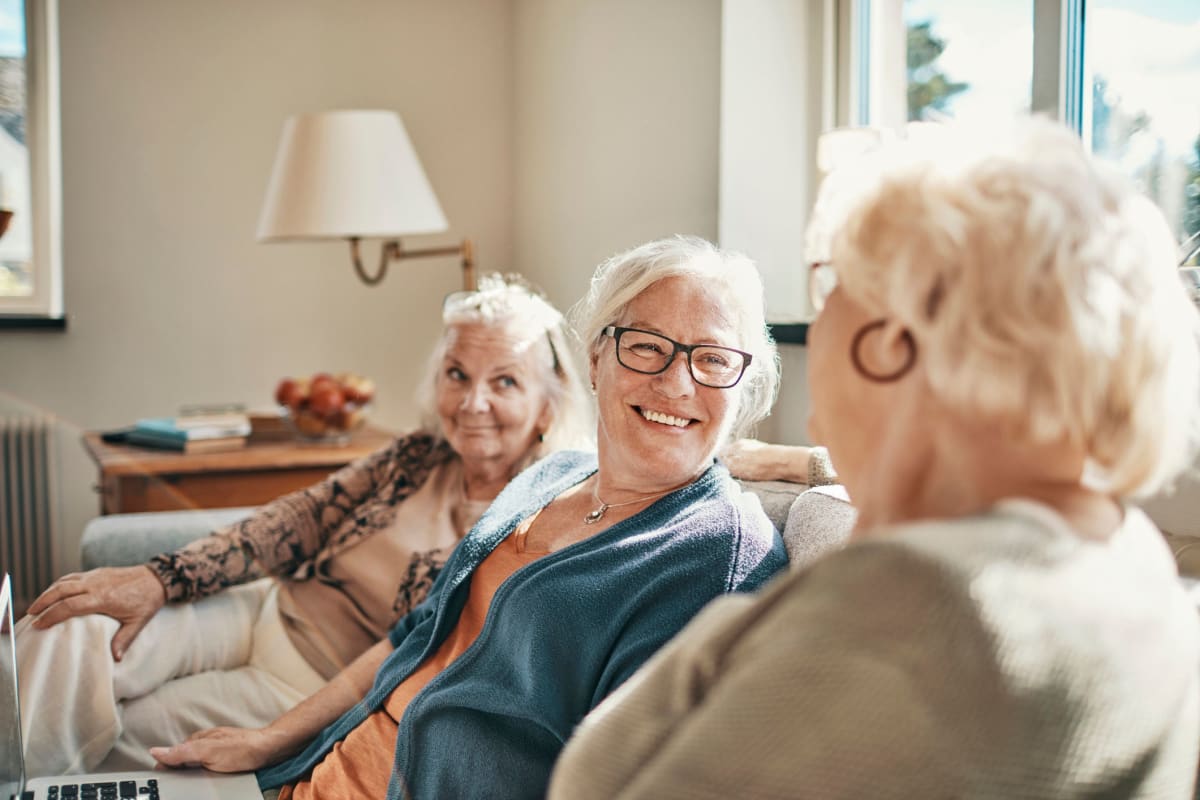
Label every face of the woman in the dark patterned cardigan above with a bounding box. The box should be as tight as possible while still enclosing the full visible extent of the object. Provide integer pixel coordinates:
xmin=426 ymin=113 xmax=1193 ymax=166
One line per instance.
xmin=434 ymin=323 xmax=550 ymax=474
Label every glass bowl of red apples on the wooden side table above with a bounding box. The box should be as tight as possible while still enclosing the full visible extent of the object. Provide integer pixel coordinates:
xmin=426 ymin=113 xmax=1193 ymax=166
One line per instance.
xmin=275 ymin=372 xmax=376 ymax=443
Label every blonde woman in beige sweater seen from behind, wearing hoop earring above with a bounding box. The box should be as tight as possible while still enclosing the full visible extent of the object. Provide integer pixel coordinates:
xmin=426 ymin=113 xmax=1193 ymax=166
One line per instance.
xmin=550 ymin=121 xmax=1200 ymax=800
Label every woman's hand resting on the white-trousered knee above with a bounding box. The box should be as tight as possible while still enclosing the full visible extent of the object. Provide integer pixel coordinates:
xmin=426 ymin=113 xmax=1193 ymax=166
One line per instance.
xmin=29 ymin=566 xmax=167 ymax=661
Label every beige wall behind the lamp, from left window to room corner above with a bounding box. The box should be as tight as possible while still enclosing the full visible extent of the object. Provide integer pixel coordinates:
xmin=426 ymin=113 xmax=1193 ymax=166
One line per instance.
xmin=0 ymin=0 xmax=514 ymax=569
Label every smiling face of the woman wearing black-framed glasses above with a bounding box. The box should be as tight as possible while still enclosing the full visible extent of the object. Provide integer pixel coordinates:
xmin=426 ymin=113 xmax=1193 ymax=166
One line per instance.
xmin=592 ymin=277 xmax=743 ymax=494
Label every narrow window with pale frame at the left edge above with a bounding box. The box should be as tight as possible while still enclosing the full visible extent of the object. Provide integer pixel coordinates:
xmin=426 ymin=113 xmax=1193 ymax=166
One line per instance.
xmin=0 ymin=0 xmax=62 ymax=318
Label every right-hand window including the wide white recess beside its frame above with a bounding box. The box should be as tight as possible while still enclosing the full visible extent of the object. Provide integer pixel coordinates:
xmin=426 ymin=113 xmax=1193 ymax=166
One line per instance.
xmin=719 ymin=0 xmax=1200 ymax=324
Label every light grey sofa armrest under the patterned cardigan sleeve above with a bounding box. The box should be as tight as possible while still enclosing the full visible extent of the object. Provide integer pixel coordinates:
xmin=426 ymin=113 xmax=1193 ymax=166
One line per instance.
xmin=79 ymin=507 xmax=254 ymax=570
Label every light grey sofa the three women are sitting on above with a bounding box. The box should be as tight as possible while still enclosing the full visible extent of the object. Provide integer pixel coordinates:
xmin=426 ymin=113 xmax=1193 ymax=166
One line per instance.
xmin=80 ymin=481 xmax=856 ymax=570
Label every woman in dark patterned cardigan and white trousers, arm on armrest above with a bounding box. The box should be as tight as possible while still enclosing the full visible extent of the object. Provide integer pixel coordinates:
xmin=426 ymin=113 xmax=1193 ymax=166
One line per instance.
xmin=18 ymin=275 xmax=592 ymax=775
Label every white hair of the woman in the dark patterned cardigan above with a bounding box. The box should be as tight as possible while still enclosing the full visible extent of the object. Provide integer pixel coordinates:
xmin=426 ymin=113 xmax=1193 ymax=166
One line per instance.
xmin=416 ymin=272 xmax=595 ymax=458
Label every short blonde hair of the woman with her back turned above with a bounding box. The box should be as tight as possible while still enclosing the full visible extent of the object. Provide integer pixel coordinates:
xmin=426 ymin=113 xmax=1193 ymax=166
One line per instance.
xmin=818 ymin=120 xmax=1200 ymax=497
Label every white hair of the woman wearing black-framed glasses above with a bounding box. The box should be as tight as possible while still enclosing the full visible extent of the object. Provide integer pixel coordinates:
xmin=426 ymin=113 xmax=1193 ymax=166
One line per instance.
xmin=570 ymin=236 xmax=779 ymax=437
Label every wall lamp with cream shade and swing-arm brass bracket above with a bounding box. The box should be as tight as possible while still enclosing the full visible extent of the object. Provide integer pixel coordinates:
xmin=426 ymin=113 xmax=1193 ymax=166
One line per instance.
xmin=258 ymin=110 xmax=475 ymax=289
